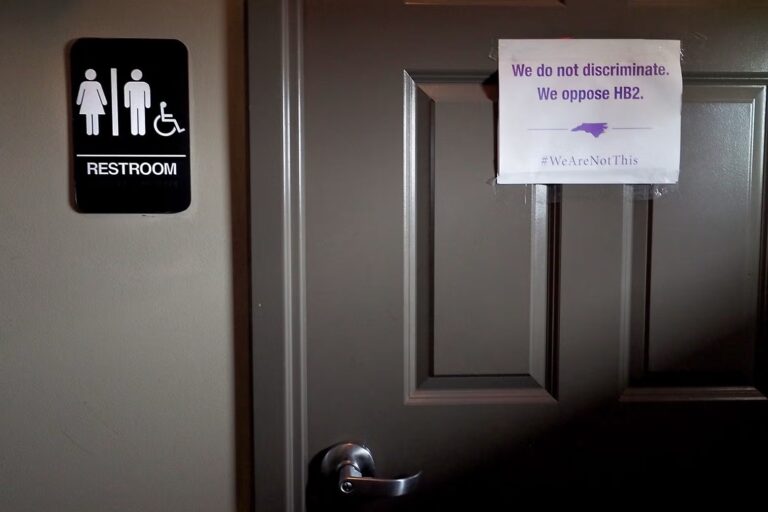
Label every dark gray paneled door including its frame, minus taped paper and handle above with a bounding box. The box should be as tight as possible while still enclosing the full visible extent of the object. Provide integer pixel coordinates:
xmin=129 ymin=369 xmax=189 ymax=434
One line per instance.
xmin=250 ymin=0 xmax=768 ymax=510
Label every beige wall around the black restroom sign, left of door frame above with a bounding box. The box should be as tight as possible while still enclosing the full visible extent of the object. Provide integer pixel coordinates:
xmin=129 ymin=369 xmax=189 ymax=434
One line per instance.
xmin=0 ymin=0 xmax=249 ymax=512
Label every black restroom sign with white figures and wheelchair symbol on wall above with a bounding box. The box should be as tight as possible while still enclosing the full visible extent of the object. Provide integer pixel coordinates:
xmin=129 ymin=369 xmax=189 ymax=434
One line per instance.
xmin=70 ymin=39 xmax=190 ymax=213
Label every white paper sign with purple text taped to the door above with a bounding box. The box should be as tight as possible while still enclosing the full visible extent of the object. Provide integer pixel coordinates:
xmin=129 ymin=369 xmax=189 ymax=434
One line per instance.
xmin=497 ymin=39 xmax=683 ymax=183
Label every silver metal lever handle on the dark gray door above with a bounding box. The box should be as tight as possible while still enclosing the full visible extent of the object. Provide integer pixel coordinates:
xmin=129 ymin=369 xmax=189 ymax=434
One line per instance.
xmin=320 ymin=443 xmax=421 ymax=497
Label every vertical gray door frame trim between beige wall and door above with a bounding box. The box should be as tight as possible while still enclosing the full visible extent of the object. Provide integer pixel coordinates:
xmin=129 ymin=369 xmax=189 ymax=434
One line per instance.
xmin=246 ymin=0 xmax=308 ymax=511
